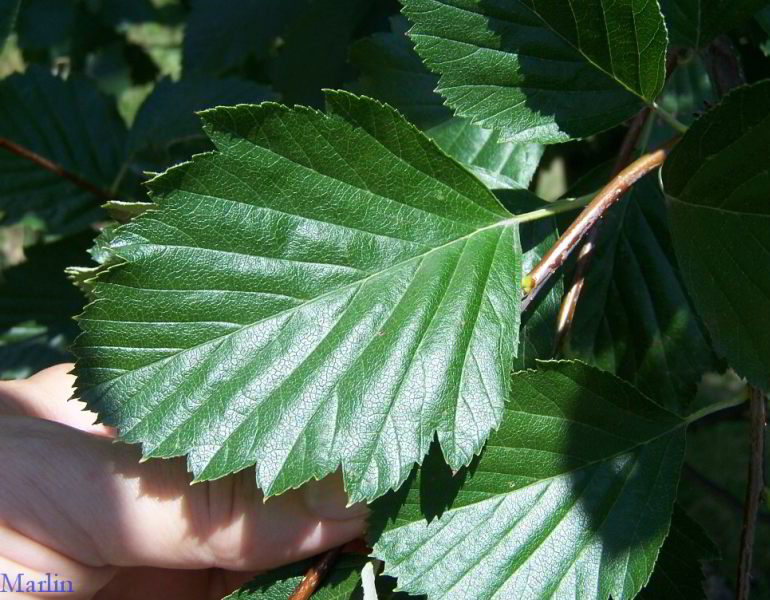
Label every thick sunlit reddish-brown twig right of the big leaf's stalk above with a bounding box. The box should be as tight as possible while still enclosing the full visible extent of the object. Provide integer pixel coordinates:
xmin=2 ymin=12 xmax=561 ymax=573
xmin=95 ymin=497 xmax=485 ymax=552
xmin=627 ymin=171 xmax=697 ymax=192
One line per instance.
xmin=522 ymin=146 xmax=669 ymax=304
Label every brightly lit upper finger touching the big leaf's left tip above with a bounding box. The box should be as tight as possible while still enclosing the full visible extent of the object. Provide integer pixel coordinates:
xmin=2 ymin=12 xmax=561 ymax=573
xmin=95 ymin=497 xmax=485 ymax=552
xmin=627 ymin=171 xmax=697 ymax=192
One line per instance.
xmin=0 ymin=363 xmax=115 ymax=437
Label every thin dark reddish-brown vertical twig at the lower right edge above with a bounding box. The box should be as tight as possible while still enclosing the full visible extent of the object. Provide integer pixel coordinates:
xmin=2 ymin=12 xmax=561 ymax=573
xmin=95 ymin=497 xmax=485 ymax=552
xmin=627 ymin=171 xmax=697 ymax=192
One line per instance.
xmin=735 ymin=386 xmax=767 ymax=600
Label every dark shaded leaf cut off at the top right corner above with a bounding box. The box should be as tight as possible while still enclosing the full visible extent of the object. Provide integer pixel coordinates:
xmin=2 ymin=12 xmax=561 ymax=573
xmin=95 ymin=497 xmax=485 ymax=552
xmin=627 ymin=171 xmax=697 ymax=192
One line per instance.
xmin=660 ymin=0 xmax=767 ymax=49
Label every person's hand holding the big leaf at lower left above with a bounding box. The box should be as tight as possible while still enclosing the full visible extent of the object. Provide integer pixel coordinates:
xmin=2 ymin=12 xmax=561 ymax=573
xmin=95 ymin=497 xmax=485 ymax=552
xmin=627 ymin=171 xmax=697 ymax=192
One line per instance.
xmin=0 ymin=365 xmax=366 ymax=600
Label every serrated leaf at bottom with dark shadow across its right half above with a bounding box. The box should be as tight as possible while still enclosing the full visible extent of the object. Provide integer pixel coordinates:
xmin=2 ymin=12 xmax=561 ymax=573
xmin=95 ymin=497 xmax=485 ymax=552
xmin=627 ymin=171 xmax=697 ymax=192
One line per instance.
xmin=370 ymin=362 xmax=685 ymax=600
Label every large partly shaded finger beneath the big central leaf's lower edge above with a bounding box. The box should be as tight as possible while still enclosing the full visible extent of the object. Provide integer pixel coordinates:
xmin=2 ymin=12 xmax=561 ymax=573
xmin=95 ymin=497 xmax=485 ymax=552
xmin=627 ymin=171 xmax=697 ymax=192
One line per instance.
xmin=0 ymin=417 xmax=364 ymax=570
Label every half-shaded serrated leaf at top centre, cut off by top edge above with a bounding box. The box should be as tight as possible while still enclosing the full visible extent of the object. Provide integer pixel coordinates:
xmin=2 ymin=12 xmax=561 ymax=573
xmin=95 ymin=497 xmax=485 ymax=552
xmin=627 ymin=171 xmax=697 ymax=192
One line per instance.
xmin=402 ymin=0 xmax=666 ymax=143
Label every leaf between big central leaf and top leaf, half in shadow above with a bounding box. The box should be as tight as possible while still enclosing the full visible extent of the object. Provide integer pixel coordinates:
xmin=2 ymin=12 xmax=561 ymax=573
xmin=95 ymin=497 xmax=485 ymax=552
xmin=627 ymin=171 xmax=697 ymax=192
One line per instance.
xmin=351 ymin=19 xmax=543 ymax=189
